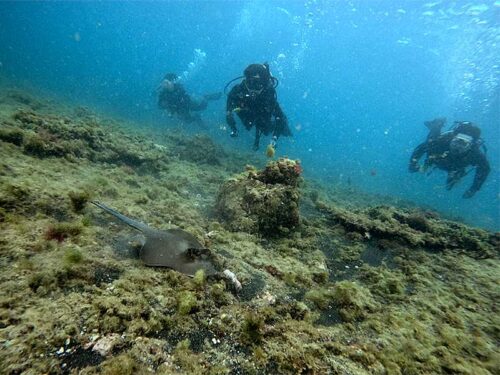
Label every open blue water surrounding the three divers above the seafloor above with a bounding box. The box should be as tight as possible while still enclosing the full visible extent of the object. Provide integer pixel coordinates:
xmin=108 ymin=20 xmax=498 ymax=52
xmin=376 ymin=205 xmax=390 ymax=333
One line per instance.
xmin=0 ymin=0 xmax=500 ymax=230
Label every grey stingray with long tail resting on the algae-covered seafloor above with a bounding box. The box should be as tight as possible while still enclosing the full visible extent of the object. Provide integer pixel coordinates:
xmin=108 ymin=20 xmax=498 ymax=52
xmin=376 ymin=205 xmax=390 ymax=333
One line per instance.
xmin=92 ymin=202 xmax=217 ymax=276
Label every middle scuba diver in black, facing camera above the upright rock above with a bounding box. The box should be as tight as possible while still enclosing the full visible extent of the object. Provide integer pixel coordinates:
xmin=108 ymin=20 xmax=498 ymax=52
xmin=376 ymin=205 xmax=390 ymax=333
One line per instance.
xmin=224 ymin=63 xmax=292 ymax=150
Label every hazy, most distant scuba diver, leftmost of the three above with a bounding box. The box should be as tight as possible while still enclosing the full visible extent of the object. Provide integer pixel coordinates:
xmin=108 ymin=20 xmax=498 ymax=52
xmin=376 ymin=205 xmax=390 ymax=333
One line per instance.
xmin=157 ymin=73 xmax=222 ymax=125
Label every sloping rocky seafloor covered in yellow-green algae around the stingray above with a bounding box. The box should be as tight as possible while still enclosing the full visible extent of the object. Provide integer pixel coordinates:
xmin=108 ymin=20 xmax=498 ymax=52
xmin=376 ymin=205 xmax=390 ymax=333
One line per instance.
xmin=0 ymin=90 xmax=500 ymax=375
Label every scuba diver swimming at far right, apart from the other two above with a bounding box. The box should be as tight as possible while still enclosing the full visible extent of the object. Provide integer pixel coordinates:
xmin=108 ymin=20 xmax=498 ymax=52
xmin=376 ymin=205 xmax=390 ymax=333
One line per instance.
xmin=409 ymin=118 xmax=490 ymax=198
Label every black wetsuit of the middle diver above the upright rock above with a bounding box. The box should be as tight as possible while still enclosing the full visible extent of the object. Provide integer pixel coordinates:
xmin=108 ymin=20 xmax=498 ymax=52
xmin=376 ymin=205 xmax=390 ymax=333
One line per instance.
xmin=226 ymin=81 xmax=292 ymax=149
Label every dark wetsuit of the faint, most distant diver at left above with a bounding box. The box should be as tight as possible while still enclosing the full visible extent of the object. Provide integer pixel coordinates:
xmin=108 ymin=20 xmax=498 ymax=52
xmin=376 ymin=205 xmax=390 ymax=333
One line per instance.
xmin=158 ymin=83 xmax=208 ymax=123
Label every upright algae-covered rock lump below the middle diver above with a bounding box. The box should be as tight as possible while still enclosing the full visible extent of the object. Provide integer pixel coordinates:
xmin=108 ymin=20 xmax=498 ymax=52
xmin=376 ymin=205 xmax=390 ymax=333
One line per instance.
xmin=215 ymin=159 xmax=302 ymax=237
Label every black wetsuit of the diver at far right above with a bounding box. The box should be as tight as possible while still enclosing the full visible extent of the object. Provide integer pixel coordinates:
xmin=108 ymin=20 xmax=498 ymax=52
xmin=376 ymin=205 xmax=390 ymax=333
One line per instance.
xmin=410 ymin=131 xmax=490 ymax=198
